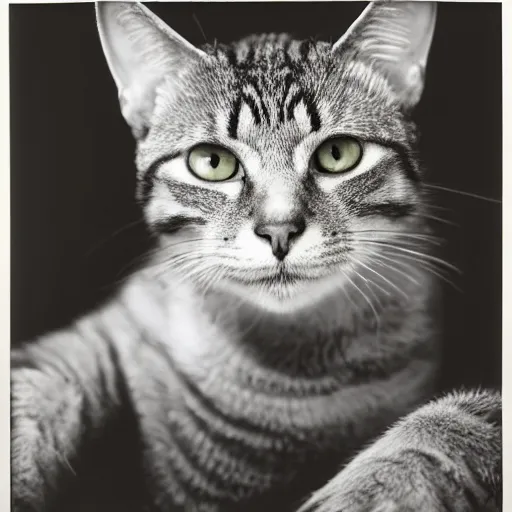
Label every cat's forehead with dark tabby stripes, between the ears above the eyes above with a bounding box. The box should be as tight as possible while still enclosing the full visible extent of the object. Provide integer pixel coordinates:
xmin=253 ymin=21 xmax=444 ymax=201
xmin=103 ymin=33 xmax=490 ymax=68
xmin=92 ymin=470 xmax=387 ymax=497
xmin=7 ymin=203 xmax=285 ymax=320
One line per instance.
xmin=150 ymin=38 xmax=396 ymax=138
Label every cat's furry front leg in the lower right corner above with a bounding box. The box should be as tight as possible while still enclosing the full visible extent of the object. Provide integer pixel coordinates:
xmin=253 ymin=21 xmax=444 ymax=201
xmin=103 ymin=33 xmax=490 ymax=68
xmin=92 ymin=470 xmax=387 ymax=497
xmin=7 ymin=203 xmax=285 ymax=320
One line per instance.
xmin=299 ymin=391 xmax=502 ymax=512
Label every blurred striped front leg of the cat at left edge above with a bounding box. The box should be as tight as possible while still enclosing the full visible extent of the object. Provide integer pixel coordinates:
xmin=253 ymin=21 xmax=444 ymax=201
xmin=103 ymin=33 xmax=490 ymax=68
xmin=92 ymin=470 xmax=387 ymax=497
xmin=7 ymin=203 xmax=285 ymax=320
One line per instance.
xmin=11 ymin=329 xmax=124 ymax=512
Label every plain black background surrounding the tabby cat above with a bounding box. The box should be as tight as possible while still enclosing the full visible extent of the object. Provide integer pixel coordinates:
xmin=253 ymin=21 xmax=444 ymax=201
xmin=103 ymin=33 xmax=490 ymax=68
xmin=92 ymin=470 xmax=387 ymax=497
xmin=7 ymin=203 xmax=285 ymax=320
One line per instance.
xmin=10 ymin=2 xmax=502 ymax=386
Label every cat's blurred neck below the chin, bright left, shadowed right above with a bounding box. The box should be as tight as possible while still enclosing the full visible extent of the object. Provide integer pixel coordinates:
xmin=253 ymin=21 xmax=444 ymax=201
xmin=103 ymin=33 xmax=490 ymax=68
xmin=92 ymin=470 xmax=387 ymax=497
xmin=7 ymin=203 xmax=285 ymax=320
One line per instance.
xmin=126 ymin=264 xmax=425 ymax=388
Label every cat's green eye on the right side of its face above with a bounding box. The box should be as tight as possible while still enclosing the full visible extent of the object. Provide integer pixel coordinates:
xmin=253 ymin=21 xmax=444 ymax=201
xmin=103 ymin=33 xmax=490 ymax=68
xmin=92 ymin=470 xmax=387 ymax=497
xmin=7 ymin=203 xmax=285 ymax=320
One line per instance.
xmin=315 ymin=137 xmax=363 ymax=173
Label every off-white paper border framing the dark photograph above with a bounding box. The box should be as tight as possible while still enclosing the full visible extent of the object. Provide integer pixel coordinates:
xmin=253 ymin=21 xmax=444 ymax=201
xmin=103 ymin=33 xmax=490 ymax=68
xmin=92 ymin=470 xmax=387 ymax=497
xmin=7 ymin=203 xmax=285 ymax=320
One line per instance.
xmin=0 ymin=0 xmax=512 ymax=511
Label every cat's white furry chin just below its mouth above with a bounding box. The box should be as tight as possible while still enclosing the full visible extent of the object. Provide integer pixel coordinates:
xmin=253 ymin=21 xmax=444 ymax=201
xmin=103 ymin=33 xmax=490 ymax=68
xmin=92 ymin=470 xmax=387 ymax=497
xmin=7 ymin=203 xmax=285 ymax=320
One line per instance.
xmin=221 ymin=275 xmax=343 ymax=313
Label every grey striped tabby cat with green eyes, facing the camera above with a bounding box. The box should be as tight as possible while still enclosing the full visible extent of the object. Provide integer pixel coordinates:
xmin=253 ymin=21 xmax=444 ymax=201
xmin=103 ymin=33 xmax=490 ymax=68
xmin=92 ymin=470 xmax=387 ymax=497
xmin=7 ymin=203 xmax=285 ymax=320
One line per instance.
xmin=11 ymin=2 xmax=502 ymax=512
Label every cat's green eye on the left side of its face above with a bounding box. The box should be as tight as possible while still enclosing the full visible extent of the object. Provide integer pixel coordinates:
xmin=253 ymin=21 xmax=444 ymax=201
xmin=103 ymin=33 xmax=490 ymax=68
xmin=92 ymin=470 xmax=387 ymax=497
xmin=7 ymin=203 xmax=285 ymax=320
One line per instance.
xmin=188 ymin=144 xmax=238 ymax=181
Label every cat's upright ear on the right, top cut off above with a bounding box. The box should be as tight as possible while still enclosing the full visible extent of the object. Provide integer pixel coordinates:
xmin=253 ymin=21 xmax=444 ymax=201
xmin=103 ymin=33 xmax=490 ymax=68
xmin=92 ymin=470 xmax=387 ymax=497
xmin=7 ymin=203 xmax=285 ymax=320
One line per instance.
xmin=333 ymin=1 xmax=436 ymax=107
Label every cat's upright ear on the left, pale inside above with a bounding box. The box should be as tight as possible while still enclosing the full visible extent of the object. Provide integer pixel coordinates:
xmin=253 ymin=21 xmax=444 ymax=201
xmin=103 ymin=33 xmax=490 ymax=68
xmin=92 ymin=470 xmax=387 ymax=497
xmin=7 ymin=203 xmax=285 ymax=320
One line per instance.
xmin=96 ymin=2 xmax=206 ymax=138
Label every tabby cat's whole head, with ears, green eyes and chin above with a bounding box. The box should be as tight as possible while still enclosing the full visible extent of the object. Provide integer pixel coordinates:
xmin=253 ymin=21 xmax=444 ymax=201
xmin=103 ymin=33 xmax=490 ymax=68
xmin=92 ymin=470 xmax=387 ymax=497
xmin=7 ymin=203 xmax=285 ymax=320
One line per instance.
xmin=97 ymin=2 xmax=436 ymax=309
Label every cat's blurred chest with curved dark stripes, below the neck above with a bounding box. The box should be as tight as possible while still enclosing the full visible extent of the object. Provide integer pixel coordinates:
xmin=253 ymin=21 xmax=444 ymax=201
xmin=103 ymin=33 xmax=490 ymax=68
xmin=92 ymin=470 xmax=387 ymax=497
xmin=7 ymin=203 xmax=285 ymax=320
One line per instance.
xmin=127 ymin=354 xmax=432 ymax=511
